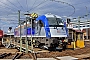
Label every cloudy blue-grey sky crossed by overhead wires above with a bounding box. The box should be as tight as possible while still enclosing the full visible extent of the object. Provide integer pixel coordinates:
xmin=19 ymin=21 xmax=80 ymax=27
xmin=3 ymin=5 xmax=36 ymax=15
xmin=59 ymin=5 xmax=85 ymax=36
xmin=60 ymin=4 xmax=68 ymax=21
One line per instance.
xmin=0 ymin=0 xmax=90 ymax=31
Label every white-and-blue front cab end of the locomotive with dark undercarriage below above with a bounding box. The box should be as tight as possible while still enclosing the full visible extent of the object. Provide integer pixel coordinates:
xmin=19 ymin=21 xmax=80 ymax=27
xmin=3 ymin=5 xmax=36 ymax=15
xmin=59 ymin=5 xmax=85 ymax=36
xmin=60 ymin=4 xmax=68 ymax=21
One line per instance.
xmin=34 ymin=14 xmax=67 ymax=50
